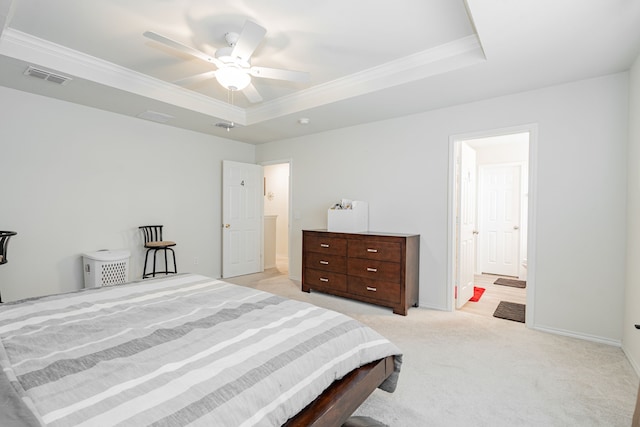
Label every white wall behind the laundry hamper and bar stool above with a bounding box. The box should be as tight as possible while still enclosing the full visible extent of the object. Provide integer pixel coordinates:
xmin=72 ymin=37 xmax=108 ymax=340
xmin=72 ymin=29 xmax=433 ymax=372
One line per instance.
xmin=0 ymin=87 xmax=255 ymax=301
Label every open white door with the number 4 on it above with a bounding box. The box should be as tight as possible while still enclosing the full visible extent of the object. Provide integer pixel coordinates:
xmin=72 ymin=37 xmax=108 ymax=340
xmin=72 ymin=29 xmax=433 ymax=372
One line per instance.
xmin=222 ymin=160 xmax=263 ymax=277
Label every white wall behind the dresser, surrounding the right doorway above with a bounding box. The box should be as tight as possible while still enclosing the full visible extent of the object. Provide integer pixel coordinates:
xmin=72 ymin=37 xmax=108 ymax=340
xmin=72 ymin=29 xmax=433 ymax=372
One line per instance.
xmin=256 ymin=73 xmax=628 ymax=343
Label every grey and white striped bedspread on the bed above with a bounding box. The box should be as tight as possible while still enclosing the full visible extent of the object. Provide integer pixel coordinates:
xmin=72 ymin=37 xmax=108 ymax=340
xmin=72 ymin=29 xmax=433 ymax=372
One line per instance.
xmin=0 ymin=275 xmax=401 ymax=427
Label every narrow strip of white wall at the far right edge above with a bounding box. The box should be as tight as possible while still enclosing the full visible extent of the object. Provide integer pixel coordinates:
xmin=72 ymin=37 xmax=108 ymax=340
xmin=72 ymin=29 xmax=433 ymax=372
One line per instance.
xmin=622 ymin=56 xmax=640 ymax=374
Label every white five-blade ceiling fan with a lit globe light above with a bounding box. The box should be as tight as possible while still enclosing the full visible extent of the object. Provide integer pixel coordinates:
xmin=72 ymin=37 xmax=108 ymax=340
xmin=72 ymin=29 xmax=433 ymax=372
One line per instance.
xmin=144 ymin=21 xmax=310 ymax=103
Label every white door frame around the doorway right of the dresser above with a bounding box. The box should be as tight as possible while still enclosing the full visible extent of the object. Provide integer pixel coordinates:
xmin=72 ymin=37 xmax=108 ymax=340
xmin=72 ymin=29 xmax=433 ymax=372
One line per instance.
xmin=446 ymin=123 xmax=538 ymax=328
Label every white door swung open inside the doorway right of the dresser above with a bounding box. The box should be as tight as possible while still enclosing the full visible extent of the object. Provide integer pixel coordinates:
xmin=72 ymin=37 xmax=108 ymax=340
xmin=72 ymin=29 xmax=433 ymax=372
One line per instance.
xmin=456 ymin=142 xmax=477 ymax=308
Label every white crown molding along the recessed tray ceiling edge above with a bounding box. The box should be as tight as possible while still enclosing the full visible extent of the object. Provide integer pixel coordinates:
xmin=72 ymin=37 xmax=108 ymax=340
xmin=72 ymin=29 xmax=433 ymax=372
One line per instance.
xmin=0 ymin=28 xmax=486 ymax=126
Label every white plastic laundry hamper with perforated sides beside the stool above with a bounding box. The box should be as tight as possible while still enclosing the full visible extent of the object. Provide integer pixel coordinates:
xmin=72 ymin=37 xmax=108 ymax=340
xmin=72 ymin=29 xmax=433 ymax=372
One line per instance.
xmin=82 ymin=250 xmax=131 ymax=288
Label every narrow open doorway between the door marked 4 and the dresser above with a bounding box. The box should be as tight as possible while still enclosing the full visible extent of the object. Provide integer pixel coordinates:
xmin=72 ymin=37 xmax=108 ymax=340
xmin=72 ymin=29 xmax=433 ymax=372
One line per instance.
xmin=263 ymin=161 xmax=290 ymax=275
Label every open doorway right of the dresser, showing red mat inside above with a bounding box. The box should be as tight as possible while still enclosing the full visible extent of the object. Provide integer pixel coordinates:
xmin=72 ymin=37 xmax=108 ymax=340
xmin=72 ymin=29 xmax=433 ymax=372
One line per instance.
xmin=449 ymin=126 xmax=536 ymax=324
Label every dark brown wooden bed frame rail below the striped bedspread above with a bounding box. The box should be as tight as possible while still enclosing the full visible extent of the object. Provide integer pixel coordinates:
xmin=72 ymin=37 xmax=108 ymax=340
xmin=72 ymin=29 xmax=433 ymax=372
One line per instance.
xmin=284 ymin=356 xmax=394 ymax=427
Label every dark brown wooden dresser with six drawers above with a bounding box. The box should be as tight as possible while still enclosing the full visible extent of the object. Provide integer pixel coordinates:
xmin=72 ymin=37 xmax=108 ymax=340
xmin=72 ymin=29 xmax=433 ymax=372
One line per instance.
xmin=302 ymin=230 xmax=420 ymax=316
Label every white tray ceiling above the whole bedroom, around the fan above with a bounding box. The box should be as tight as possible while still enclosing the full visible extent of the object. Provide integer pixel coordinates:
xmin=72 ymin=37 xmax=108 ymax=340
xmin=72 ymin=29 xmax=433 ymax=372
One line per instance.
xmin=0 ymin=0 xmax=640 ymax=144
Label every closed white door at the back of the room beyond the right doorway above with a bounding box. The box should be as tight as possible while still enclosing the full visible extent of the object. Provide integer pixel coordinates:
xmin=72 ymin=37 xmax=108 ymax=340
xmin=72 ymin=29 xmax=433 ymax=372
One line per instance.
xmin=479 ymin=165 xmax=520 ymax=277
